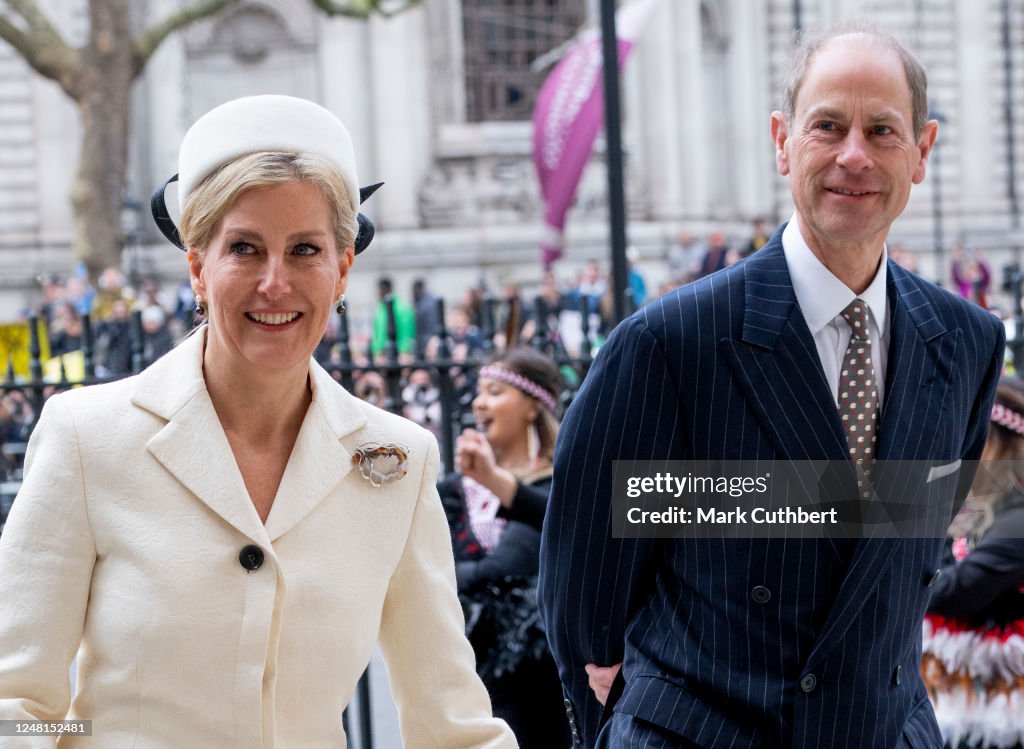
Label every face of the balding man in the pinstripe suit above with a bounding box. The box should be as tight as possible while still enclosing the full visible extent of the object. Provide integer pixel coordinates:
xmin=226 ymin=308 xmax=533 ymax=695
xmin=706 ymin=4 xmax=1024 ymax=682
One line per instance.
xmin=771 ymin=34 xmax=938 ymax=258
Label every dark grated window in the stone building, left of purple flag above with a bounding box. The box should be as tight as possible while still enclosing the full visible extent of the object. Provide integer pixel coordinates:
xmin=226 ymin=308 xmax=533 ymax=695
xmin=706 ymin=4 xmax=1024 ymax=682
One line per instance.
xmin=462 ymin=0 xmax=587 ymax=122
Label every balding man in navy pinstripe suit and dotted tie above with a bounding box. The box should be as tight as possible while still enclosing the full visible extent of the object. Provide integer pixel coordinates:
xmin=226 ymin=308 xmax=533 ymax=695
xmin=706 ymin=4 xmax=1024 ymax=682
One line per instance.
xmin=540 ymin=26 xmax=1004 ymax=749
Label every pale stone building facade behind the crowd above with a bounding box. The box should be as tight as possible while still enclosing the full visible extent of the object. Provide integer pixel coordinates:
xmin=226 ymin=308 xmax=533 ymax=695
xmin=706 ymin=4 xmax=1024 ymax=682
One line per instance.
xmin=0 ymin=0 xmax=1024 ymax=319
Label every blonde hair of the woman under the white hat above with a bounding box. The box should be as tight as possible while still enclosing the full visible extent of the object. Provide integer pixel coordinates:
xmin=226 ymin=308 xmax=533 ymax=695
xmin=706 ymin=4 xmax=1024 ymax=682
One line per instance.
xmin=180 ymin=152 xmax=358 ymax=252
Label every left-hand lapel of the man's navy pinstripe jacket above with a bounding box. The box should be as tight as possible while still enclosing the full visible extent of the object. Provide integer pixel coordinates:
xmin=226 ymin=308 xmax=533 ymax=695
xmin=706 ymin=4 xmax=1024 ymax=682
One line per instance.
xmin=719 ymin=239 xmax=847 ymax=460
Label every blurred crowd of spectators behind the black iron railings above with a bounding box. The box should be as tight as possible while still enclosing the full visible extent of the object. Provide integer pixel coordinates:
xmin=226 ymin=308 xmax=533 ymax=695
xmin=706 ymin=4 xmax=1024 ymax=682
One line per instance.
xmin=6 ymin=218 xmax=1015 ymax=475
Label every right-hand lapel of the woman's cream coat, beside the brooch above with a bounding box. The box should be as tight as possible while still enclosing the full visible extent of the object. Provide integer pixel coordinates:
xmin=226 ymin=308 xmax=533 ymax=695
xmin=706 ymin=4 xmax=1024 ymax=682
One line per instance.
xmin=266 ymin=362 xmax=367 ymax=541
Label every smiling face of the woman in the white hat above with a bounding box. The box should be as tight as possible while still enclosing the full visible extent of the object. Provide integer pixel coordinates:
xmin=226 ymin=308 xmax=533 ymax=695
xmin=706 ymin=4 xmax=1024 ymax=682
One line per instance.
xmin=188 ymin=180 xmax=353 ymax=372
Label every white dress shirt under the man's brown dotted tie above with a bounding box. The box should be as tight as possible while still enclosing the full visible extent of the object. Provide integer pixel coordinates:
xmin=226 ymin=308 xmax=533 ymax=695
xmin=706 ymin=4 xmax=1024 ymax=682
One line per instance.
xmin=782 ymin=214 xmax=890 ymax=408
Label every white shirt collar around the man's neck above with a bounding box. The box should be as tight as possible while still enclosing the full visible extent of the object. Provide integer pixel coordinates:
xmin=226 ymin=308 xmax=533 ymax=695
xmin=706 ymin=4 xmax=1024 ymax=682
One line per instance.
xmin=782 ymin=214 xmax=889 ymax=336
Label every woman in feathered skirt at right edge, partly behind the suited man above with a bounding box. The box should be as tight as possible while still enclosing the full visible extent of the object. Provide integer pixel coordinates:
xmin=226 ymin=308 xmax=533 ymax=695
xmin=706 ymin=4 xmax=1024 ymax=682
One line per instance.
xmin=923 ymin=377 xmax=1024 ymax=749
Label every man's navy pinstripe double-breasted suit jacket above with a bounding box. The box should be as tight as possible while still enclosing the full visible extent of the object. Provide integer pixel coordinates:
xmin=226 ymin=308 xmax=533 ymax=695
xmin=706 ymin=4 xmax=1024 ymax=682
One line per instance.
xmin=540 ymin=230 xmax=1005 ymax=749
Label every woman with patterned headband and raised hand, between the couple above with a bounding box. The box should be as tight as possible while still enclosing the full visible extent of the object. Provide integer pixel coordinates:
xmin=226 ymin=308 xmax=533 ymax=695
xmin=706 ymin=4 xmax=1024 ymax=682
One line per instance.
xmin=438 ymin=346 xmax=571 ymax=749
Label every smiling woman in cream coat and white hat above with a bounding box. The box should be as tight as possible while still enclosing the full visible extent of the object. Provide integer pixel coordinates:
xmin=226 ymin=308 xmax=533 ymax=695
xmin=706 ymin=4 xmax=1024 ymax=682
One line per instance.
xmin=0 ymin=96 xmax=515 ymax=749
